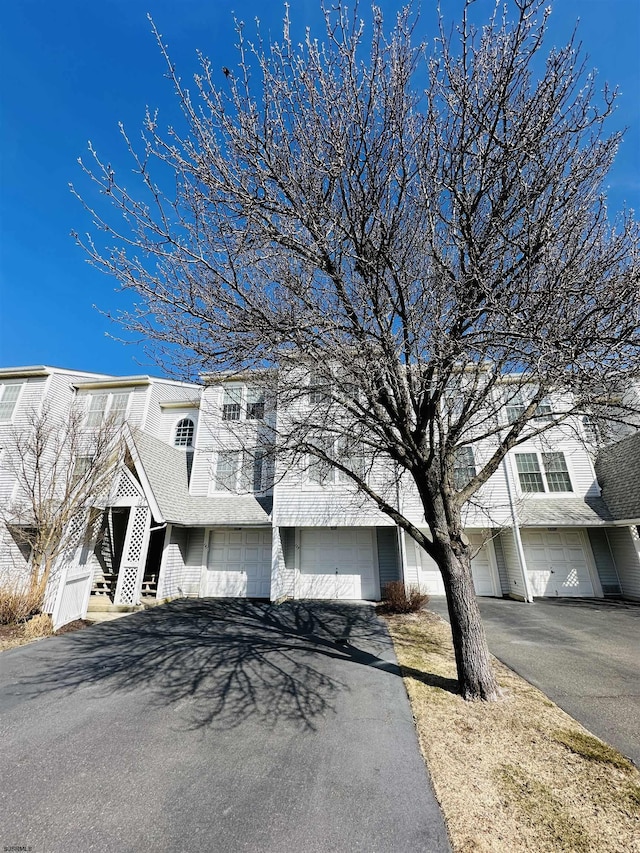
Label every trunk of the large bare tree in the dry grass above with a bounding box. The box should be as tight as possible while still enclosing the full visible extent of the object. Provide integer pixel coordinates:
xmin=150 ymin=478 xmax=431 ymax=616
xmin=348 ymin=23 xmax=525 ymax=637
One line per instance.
xmin=434 ymin=534 xmax=501 ymax=702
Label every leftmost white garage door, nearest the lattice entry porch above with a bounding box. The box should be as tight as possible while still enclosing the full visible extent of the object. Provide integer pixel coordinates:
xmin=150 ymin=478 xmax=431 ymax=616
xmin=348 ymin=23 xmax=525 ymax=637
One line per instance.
xmin=207 ymin=528 xmax=271 ymax=598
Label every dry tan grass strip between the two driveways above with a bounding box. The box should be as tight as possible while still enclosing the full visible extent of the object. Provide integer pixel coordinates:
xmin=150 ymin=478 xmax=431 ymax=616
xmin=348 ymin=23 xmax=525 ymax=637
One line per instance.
xmin=387 ymin=611 xmax=640 ymax=853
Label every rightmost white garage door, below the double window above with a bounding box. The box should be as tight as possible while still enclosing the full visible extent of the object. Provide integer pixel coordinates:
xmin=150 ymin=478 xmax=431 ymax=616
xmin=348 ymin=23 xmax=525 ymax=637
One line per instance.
xmin=522 ymin=530 xmax=593 ymax=597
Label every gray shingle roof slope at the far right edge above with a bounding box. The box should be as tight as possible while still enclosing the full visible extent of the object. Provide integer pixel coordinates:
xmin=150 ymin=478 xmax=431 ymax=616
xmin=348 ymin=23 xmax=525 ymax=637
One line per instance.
xmin=596 ymin=432 xmax=640 ymax=521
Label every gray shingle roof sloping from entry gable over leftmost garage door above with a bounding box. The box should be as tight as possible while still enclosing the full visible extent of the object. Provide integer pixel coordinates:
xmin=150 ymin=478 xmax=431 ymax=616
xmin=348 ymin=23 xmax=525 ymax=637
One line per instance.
xmin=131 ymin=428 xmax=269 ymax=527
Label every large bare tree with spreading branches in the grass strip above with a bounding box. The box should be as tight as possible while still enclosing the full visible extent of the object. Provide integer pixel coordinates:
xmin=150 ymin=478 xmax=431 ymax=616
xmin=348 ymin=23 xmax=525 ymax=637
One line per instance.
xmin=72 ymin=0 xmax=640 ymax=699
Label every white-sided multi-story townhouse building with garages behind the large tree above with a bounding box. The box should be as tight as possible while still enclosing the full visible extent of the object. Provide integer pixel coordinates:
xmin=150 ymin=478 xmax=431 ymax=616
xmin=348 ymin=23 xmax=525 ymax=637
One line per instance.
xmin=0 ymin=360 xmax=640 ymax=624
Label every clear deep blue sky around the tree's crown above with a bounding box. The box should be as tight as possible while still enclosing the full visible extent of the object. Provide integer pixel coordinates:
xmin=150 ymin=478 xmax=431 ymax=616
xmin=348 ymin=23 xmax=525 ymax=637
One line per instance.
xmin=0 ymin=0 xmax=640 ymax=374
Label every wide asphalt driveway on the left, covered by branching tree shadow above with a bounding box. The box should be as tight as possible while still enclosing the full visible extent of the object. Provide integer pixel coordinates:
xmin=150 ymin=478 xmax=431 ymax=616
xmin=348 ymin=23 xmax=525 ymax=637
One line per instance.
xmin=0 ymin=599 xmax=449 ymax=853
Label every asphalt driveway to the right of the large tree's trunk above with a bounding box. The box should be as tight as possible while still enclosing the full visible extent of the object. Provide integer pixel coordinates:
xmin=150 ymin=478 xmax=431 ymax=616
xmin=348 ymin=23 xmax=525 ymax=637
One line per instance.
xmin=428 ymin=597 xmax=640 ymax=767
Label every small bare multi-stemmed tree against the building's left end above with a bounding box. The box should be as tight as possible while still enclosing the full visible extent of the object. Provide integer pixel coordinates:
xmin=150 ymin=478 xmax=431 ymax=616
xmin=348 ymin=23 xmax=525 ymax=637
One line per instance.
xmin=0 ymin=399 xmax=119 ymax=603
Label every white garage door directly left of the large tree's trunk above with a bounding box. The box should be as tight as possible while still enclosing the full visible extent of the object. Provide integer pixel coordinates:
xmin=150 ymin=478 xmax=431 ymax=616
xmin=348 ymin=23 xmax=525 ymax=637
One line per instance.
xmin=298 ymin=527 xmax=379 ymax=599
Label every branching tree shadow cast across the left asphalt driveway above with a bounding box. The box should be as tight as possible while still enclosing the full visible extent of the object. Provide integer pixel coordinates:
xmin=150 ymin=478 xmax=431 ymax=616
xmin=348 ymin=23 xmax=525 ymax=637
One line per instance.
xmin=13 ymin=599 xmax=457 ymax=729
